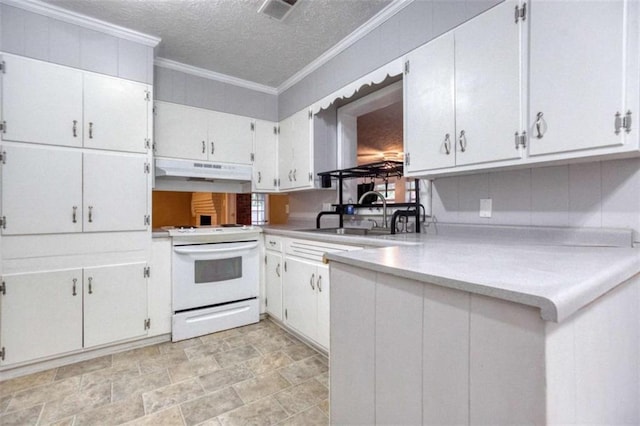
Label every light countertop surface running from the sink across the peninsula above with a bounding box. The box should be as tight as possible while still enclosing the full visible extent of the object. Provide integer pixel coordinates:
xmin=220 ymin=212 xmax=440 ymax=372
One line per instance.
xmin=265 ymin=225 xmax=640 ymax=322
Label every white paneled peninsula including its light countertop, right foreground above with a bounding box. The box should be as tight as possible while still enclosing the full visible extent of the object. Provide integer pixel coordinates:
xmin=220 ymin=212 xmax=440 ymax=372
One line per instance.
xmin=266 ymin=224 xmax=640 ymax=424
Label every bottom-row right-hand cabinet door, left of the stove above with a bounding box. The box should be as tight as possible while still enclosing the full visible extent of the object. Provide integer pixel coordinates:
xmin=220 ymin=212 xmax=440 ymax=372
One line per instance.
xmin=84 ymin=262 xmax=147 ymax=348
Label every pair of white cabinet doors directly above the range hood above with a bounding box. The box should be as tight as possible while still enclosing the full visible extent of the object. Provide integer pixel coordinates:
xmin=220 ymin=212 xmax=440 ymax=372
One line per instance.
xmin=154 ymin=101 xmax=253 ymax=164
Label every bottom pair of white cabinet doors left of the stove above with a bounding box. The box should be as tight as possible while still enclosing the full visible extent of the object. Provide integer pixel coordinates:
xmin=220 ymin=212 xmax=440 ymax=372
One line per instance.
xmin=0 ymin=262 xmax=148 ymax=365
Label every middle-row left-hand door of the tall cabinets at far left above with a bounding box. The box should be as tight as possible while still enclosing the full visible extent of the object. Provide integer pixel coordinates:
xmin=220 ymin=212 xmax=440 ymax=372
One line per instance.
xmin=1 ymin=145 xmax=82 ymax=235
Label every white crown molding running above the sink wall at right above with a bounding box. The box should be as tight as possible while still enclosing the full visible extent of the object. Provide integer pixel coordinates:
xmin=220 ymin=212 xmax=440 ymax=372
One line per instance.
xmin=277 ymin=0 xmax=414 ymax=94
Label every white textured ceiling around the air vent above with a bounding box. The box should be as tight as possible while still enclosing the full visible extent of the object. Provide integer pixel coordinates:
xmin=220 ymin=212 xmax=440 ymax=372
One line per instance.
xmin=44 ymin=0 xmax=391 ymax=87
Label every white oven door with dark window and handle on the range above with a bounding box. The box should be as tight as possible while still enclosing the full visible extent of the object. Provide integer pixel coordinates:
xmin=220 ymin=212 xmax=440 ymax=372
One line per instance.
xmin=173 ymin=241 xmax=259 ymax=312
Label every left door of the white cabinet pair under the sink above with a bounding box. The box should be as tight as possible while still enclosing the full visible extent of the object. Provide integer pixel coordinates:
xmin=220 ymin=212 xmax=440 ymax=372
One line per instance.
xmin=283 ymin=257 xmax=318 ymax=341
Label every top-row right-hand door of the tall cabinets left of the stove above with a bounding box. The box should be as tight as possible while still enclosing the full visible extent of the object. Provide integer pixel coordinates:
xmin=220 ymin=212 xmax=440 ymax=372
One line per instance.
xmin=84 ymin=73 xmax=151 ymax=152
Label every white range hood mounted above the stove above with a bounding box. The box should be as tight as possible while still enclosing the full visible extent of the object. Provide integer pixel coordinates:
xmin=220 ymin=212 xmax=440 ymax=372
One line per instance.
xmin=153 ymin=158 xmax=253 ymax=193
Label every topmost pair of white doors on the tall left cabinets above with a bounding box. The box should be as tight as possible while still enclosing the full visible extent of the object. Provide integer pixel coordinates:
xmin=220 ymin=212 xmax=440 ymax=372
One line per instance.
xmin=2 ymin=55 xmax=151 ymax=152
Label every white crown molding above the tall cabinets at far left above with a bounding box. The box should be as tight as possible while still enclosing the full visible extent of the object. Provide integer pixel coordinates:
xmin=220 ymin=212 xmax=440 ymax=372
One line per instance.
xmin=0 ymin=0 xmax=161 ymax=47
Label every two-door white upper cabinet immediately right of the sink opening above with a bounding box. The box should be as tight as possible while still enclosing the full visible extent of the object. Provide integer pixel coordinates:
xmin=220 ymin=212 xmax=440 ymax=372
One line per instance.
xmin=404 ymin=1 xmax=522 ymax=176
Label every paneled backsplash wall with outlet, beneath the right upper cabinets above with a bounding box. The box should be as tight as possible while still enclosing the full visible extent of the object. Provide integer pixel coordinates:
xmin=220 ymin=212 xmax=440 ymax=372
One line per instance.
xmin=433 ymin=158 xmax=640 ymax=241
